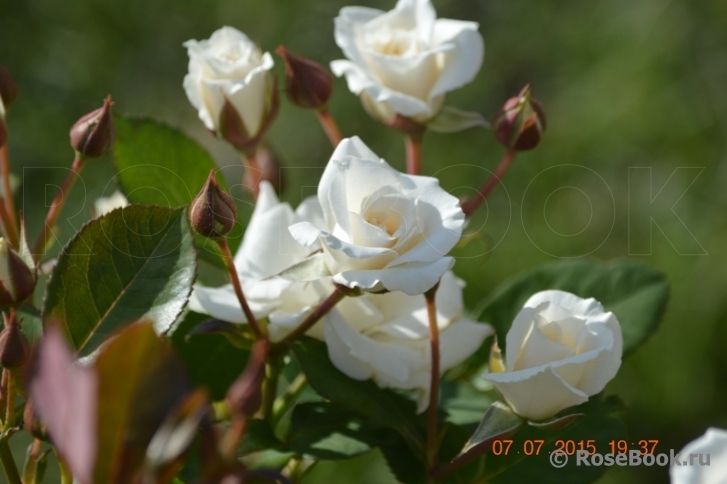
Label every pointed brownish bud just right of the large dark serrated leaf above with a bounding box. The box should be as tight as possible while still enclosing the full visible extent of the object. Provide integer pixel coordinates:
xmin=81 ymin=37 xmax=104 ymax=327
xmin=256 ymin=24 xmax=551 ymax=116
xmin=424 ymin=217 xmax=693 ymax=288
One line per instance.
xmin=189 ymin=170 xmax=237 ymax=238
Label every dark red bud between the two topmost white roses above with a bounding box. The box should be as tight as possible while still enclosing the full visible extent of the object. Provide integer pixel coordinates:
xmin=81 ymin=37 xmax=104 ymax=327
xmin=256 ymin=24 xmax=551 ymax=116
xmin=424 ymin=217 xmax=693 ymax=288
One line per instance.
xmin=275 ymin=45 xmax=333 ymax=109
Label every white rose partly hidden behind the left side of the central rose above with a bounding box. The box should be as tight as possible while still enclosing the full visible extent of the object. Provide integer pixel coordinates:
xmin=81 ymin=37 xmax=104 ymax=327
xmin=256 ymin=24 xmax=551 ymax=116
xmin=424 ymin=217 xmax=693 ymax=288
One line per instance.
xmin=189 ymin=181 xmax=333 ymax=341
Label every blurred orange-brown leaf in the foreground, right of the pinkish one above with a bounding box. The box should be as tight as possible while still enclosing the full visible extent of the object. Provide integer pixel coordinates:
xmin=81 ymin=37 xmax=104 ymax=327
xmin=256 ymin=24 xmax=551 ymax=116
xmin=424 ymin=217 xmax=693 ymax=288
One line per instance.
xmin=94 ymin=323 xmax=191 ymax=483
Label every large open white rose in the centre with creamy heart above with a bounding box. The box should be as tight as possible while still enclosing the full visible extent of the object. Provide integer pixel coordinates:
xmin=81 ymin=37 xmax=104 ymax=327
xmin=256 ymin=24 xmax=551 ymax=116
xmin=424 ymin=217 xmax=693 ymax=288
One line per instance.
xmin=290 ymin=138 xmax=464 ymax=295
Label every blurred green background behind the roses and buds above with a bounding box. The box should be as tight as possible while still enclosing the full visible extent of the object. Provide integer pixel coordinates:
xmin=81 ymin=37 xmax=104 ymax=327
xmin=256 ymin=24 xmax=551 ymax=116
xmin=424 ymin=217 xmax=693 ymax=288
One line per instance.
xmin=0 ymin=0 xmax=727 ymax=483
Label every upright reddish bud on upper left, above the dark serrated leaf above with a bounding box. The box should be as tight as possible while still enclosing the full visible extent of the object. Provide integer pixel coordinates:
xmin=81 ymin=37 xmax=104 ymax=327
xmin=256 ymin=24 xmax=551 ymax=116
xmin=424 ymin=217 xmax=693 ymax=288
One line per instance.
xmin=71 ymin=96 xmax=115 ymax=158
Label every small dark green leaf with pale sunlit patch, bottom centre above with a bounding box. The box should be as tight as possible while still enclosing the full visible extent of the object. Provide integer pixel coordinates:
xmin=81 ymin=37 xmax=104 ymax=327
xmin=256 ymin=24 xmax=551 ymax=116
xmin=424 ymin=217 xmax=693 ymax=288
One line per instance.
xmin=287 ymin=402 xmax=371 ymax=460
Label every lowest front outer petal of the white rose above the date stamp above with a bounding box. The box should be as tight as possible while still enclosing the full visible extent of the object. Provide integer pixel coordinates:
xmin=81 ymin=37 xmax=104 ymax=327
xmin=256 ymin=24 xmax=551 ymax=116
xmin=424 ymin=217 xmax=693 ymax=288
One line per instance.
xmin=483 ymin=366 xmax=588 ymax=420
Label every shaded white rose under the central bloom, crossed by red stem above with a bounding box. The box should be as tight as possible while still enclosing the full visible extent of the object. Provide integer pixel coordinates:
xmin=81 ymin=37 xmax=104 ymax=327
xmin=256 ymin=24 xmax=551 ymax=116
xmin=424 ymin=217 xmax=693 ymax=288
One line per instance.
xmin=324 ymin=272 xmax=494 ymax=412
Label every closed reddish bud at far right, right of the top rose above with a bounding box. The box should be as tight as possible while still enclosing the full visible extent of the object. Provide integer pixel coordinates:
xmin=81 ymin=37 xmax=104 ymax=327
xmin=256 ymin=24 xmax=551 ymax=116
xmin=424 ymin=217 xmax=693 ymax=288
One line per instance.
xmin=493 ymin=85 xmax=546 ymax=151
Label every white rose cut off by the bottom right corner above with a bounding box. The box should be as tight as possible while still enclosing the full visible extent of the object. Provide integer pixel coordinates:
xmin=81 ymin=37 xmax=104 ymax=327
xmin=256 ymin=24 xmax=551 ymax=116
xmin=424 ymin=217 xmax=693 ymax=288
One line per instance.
xmin=669 ymin=428 xmax=727 ymax=484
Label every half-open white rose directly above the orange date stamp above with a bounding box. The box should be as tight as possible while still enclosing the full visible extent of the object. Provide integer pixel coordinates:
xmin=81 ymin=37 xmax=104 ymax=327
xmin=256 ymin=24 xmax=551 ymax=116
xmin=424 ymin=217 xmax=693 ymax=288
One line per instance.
xmin=484 ymin=291 xmax=623 ymax=420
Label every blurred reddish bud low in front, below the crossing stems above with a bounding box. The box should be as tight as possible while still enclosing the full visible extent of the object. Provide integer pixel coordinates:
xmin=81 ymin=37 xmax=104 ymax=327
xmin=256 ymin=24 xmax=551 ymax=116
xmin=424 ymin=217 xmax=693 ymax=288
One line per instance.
xmin=227 ymin=339 xmax=270 ymax=417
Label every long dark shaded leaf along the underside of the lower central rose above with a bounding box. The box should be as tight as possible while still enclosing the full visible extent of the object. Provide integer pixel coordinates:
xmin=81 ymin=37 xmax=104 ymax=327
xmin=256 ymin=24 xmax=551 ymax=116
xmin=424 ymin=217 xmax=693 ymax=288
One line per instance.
xmin=292 ymin=338 xmax=424 ymax=455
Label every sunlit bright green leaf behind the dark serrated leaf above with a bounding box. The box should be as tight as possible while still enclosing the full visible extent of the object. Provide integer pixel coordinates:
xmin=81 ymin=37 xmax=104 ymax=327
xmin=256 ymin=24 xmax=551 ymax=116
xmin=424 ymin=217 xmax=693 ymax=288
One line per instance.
xmin=114 ymin=115 xmax=224 ymax=207
